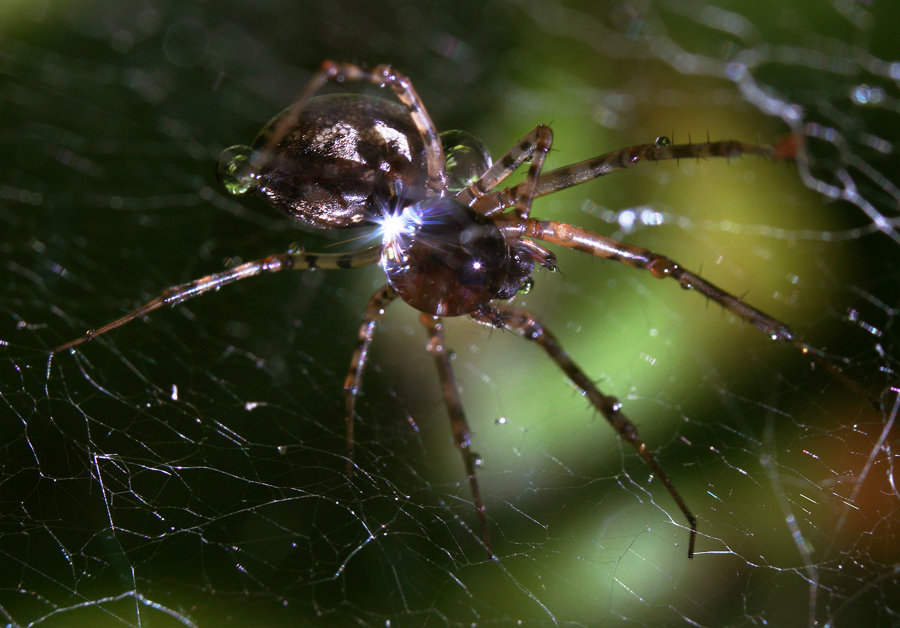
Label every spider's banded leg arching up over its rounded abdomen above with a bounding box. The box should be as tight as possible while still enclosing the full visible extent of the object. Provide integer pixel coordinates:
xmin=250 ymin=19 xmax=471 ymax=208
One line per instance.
xmin=260 ymin=61 xmax=447 ymax=194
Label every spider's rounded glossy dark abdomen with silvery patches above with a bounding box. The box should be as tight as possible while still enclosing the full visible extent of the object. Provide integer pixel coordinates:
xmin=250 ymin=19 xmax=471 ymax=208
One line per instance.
xmin=217 ymin=94 xmax=426 ymax=229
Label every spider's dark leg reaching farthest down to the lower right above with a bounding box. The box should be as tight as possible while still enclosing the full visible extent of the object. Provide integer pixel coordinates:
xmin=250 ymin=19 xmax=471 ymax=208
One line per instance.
xmin=470 ymin=307 xmax=697 ymax=558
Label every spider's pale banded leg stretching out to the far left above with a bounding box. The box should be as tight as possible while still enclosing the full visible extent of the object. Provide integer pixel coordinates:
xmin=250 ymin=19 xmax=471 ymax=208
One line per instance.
xmin=51 ymin=245 xmax=381 ymax=353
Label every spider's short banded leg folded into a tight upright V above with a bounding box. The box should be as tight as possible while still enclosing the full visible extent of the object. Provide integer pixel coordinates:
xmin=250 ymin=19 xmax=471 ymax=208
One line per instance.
xmin=455 ymin=124 xmax=553 ymax=218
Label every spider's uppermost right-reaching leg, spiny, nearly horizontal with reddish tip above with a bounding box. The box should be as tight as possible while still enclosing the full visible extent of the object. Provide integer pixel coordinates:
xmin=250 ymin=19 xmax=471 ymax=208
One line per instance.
xmin=476 ymin=136 xmax=784 ymax=216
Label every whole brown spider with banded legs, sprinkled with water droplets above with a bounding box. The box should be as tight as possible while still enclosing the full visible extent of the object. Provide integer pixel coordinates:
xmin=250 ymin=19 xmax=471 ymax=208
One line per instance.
xmin=53 ymin=62 xmax=824 ymax=558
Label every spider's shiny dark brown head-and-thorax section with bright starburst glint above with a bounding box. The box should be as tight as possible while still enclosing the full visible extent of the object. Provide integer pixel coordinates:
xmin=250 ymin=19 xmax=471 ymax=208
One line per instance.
xmin=381 ymin=197 xmax=534 ymax=316
